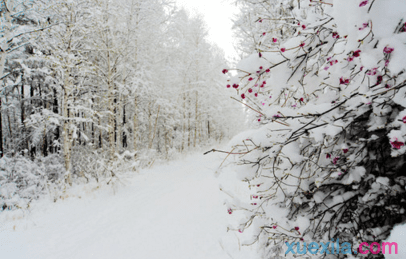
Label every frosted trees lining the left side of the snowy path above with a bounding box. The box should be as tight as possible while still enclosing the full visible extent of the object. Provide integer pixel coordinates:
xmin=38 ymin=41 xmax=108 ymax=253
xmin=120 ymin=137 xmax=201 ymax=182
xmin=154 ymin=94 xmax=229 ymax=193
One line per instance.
xmin=0 ymin=0 xmax=244 ymax=209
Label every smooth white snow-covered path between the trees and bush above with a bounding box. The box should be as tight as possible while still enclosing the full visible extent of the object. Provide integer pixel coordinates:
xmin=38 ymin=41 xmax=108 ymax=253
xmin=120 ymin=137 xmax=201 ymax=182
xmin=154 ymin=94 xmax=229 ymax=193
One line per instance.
xmin=0 ymin=153 xmax=256 ymax=259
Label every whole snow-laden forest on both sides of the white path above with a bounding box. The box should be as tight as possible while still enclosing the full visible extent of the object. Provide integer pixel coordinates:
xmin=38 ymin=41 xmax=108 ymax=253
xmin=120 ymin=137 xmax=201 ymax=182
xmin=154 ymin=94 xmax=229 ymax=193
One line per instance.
xmin=0 ymin=0 xmax=406 ymax=258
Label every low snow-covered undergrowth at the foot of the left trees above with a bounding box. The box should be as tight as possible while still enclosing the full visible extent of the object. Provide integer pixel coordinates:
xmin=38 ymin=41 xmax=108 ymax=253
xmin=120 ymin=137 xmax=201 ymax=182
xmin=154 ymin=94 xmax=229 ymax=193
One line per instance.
xmin=0 ymin=150 xmax=137 ymax=211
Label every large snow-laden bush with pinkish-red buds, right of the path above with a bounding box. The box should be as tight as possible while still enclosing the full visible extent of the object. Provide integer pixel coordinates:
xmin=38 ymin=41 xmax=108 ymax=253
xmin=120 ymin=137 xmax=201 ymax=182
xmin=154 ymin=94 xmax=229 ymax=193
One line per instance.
xmin=223 ymin=0 xmax=406 ymax=258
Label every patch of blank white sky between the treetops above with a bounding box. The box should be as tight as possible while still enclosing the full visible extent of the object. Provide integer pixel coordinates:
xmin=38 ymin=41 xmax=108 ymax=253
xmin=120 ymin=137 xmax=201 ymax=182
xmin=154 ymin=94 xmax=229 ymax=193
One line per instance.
xmin=176 ymin=0 xmax=237 ymax=61
